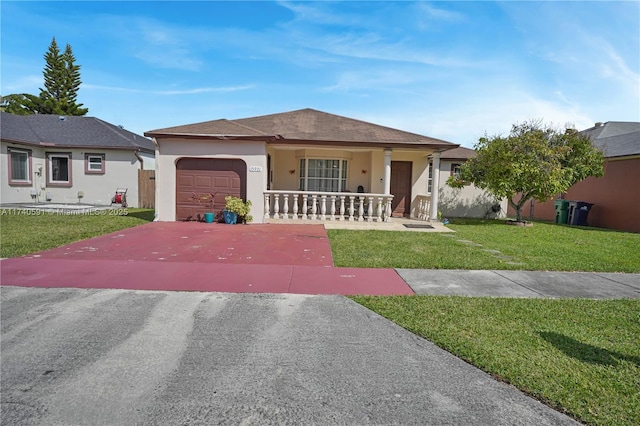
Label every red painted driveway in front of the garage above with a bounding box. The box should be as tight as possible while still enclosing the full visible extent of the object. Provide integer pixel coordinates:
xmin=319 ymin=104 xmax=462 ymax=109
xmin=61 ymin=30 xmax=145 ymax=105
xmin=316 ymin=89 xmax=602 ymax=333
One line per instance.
xmin=0 ymin=222 xmax=414 ymax=295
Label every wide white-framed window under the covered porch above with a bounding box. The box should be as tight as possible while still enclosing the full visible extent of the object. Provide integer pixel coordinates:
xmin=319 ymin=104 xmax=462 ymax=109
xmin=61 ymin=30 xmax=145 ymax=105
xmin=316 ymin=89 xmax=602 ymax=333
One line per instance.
xmin=300 ymin=158 xmax=347 ymax=192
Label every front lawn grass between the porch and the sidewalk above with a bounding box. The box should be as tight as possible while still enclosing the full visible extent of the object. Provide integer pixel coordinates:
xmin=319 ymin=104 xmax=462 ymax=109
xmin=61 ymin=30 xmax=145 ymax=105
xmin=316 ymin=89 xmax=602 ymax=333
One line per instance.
xmin=328 ymin=219 xmax=640 ymax=272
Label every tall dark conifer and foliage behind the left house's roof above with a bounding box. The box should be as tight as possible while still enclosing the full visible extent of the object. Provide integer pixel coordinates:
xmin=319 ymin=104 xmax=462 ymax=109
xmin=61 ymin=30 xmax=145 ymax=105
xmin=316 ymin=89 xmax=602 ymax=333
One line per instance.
xmin=2 ymin=37 xmax=89 ymax=115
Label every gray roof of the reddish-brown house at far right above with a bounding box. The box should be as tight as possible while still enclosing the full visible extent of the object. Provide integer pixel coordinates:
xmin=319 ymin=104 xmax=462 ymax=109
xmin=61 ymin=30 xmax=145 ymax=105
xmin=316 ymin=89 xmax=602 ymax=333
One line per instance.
xmin=580 ymin=121 xmax=640 ymax=158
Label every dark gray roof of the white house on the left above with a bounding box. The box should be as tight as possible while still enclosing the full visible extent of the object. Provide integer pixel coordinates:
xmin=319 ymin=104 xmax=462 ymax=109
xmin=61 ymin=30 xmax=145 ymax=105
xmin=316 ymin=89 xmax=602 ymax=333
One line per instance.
xmin=0 ymin=112 xmax=155 ymax=152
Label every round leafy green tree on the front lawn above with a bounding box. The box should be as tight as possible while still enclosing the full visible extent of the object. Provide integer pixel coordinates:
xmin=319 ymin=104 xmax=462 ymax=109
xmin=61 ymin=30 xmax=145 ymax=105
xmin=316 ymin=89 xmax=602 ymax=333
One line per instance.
xmin=447 ymin=121 xmax=604 ymax=222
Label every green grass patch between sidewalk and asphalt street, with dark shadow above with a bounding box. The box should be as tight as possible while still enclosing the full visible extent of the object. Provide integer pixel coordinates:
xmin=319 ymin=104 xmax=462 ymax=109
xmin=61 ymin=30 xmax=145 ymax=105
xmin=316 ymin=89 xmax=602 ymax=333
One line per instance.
xmin=352 ymin=296 xmax=640 ymax=425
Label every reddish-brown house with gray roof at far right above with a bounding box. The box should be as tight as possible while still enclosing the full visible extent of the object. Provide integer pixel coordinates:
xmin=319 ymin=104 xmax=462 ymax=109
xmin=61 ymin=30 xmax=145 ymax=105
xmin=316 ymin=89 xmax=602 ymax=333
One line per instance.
xmin=510 ymin=121 xmax=640 ymax=232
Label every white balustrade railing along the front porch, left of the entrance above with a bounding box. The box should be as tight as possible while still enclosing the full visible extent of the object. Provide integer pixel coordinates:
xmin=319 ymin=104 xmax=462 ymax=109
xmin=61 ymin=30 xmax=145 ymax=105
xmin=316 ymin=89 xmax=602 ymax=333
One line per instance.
xmin=264 ymin=190 xmax=393 ymax=222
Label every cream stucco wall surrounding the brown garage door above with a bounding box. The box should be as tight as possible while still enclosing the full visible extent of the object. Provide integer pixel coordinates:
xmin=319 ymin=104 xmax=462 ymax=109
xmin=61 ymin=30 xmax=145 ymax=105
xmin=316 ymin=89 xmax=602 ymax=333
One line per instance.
xmin=156 ymin=138 xmax=267 ymax=223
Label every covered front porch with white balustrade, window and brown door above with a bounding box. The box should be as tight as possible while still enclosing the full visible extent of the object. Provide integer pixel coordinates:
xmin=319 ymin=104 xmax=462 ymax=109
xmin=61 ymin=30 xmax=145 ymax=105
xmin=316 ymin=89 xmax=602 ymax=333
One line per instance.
xmin=261 ymin=145 xmax=440 ymax=224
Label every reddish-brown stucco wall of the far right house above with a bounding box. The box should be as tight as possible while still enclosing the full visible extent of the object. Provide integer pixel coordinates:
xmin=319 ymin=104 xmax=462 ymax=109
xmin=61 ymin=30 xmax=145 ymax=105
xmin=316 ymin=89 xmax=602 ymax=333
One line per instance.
xmin=509 ymin=158 xmax=640 ymax=232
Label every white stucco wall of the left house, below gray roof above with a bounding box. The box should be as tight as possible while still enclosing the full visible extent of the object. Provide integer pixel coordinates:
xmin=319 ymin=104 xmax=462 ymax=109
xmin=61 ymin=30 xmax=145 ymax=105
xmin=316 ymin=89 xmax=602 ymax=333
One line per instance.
xmin=0 ymin=143 xmax=140 ymax=207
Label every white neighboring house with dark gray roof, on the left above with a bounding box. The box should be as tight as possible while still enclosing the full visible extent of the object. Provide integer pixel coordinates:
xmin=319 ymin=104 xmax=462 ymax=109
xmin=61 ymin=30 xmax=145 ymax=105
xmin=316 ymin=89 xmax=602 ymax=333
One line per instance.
xmin=0 ymin=112 xmax=155 ymax=207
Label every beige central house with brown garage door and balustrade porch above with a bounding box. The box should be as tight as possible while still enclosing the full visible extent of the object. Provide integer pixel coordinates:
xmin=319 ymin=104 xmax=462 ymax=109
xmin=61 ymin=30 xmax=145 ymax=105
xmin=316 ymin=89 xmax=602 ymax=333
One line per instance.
xmin=145 ymin=109 xmax=468 ymax=223
